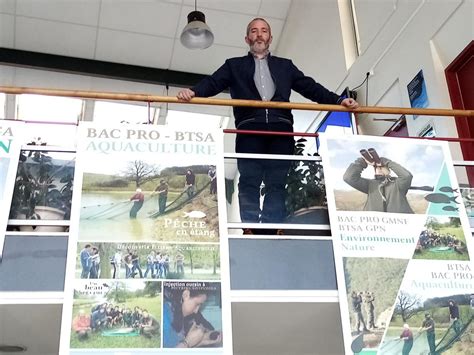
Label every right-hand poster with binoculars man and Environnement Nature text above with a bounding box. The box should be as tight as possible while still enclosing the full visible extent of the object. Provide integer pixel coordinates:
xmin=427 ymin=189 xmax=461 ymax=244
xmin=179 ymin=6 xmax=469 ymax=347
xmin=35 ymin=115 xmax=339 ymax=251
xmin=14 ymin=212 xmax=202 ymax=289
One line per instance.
xmin=321 ymin=136 xmax=474 ymax=355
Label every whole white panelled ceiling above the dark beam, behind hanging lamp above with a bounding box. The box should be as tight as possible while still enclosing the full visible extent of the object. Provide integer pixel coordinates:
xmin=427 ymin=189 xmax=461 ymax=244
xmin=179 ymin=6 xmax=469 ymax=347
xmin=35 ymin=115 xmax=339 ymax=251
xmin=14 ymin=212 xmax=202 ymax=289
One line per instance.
xmin=0 ymin=0 xmax=291 ymax=74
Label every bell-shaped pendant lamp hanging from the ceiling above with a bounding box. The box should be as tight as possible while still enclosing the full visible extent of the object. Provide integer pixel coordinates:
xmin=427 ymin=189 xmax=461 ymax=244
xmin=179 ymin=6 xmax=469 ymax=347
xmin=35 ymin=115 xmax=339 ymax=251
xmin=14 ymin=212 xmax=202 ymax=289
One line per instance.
xmin=180 ymin=0 xmax=214 ymax=49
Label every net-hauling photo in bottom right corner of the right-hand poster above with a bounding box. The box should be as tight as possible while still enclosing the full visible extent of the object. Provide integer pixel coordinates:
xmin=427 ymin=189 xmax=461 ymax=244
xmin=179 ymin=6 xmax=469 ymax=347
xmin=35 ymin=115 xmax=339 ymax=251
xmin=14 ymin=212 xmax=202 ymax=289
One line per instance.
xmin=379 ymin=290 xmax=474 ymax=355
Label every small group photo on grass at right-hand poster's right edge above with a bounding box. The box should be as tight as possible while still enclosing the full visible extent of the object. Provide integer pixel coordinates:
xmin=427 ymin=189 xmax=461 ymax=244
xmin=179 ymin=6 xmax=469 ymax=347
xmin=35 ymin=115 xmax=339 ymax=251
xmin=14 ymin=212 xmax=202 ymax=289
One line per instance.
xmin=413 ymin=216 xmax=469 ymax=260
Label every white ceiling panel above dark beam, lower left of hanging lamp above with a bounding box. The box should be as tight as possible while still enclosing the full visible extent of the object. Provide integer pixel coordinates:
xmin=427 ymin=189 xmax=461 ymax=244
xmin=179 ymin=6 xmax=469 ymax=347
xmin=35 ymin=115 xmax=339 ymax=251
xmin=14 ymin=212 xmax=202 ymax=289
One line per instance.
xmin=95 ymin=29 xmax=174 ymax=69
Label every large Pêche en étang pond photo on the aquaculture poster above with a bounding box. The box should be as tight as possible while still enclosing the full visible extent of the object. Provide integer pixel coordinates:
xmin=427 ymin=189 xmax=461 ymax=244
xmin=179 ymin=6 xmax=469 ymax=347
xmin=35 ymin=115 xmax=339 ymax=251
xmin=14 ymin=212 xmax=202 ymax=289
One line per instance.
xmin=79 ymin=160 xmax=219 ymax=242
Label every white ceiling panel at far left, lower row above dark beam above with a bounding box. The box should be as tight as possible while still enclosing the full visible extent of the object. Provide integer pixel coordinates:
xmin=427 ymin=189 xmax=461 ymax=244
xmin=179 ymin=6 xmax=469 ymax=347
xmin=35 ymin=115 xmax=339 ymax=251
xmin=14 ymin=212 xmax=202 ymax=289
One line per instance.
xmin=15 ymin=16 xmax=96 ymax=58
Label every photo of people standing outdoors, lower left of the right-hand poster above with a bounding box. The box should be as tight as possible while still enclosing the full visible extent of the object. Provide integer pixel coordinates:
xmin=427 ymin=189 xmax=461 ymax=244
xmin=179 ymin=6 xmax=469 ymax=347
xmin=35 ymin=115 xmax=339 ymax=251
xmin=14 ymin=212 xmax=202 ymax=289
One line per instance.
xmin=343 ymin=258 xmax=408 ymax=348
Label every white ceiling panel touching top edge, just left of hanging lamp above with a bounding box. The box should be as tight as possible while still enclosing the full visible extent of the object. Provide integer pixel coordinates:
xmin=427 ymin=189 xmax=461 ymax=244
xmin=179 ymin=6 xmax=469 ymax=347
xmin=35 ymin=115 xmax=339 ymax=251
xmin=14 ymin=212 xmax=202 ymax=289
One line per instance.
xmin=99 ymin=0 xmax=181 ymax=38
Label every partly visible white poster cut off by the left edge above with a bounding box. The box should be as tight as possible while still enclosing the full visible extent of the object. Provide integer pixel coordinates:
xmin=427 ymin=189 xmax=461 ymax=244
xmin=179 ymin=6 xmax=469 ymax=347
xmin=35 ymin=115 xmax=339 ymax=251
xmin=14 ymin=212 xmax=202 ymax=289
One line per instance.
xmin=0 ymin=120 xmax=23 ymax=259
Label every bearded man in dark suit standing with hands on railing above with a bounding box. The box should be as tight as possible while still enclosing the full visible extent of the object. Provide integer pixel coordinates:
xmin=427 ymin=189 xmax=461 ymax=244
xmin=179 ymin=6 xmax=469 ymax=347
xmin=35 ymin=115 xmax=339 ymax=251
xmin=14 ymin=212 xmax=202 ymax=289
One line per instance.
xmin=177 ymin=18 xmax=358 ymax=233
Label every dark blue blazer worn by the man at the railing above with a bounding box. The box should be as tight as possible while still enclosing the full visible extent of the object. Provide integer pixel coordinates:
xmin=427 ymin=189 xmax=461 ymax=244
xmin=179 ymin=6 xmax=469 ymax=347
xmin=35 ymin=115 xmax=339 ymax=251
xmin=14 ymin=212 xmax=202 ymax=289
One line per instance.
xmin=191 ymin=53 xmax=342 ymax=129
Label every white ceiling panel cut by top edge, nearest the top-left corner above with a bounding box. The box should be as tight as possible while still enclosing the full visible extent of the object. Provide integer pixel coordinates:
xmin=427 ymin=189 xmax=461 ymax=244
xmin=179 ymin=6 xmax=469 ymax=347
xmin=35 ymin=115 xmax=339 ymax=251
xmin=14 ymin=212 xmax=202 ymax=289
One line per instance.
xmin=16 ymin=0 xmax=100 ymax=26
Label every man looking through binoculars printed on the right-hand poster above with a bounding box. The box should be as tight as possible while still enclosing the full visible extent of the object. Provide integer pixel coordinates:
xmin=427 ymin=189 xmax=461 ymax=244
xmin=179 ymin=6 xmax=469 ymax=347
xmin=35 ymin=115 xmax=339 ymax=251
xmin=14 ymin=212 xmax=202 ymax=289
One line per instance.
xmin=343 ymin=150 xmax=413 ymax=213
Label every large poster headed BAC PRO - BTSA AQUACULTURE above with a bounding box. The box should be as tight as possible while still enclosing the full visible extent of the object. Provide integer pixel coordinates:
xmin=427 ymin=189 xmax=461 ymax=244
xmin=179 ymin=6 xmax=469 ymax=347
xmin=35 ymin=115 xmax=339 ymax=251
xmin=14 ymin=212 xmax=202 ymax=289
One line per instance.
xmin=60 ymin=124 xmax=231 ymax=354
